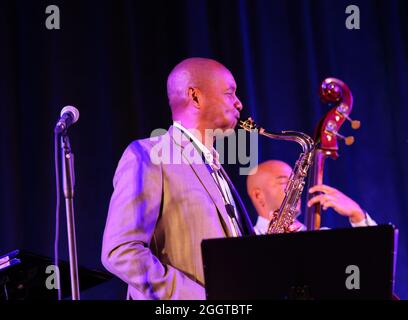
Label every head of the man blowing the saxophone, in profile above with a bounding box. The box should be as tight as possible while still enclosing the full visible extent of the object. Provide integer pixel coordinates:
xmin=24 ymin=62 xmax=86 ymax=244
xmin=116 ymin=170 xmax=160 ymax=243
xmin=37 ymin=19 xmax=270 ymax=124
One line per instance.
xmin=167 ymin=58 xmax=242 ymax=142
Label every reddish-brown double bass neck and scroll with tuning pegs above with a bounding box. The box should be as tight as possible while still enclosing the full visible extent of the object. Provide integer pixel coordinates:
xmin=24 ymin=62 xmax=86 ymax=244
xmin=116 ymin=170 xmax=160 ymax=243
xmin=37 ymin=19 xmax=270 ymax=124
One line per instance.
xmin=305 ymin=78 xmax=360 ymax=230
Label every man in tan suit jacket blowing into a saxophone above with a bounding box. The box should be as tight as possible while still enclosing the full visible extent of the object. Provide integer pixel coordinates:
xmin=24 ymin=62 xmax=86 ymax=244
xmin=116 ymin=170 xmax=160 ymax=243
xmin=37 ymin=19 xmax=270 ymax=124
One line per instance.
xmin=102 ymin=58 xmax=254 ymax=300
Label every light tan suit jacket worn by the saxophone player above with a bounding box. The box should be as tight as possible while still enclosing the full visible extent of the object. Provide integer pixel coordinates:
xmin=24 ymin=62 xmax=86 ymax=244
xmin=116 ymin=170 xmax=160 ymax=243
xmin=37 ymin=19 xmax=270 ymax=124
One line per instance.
xmin=102 ymin=127 xmax=252 ymax=299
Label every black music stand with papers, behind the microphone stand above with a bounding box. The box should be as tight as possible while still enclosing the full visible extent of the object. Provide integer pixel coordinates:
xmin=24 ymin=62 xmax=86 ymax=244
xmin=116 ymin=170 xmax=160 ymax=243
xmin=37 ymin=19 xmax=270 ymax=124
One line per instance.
xmin=0 ymin=250 xmax=113 ymax=301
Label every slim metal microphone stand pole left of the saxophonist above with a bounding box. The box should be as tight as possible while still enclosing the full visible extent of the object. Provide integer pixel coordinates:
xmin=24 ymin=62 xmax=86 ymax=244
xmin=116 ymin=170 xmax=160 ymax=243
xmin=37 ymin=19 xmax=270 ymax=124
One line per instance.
xmin=61 ymin=130 xmax=80 ymax=300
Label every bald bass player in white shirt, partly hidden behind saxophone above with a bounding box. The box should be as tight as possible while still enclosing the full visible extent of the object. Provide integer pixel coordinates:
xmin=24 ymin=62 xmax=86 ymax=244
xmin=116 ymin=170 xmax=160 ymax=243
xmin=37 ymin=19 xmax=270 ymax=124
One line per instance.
xmin=247 ymin=160 xmax=376 ymax=234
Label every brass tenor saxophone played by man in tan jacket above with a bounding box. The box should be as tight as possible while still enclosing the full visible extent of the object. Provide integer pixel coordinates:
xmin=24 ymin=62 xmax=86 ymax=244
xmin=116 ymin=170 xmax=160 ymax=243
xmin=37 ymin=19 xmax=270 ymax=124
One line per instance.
xmin=239 ymin=118 xmax=315 ymax=234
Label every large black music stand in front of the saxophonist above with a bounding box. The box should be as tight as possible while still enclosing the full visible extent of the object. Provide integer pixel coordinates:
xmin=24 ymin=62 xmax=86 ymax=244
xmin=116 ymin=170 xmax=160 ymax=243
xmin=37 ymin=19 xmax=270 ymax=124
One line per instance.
xmin=201 ymin=225 xmax=398 ymax=300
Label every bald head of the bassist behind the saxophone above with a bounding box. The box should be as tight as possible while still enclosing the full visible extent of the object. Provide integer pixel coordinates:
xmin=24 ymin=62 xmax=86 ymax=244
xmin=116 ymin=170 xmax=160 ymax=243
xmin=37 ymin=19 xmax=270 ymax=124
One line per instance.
xmin=247 ymin=160 xmax=292 ymax=218
